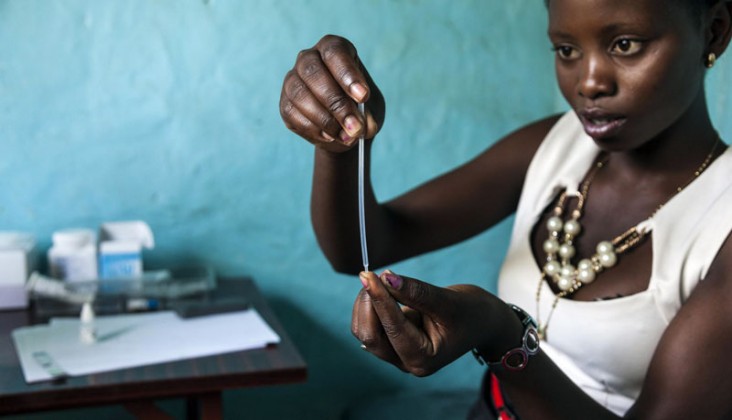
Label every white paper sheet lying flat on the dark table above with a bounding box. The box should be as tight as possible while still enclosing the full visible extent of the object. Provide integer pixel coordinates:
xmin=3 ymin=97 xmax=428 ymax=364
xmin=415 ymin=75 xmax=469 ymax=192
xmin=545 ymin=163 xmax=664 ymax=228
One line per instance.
xmin=12 ymin=309 xmax=280 ymax=383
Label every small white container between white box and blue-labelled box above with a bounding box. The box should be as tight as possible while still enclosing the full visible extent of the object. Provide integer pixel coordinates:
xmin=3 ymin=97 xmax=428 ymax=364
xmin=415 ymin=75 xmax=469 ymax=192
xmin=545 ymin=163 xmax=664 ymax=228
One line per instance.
xmin=48 ymin=229 xmax=97 ymax=282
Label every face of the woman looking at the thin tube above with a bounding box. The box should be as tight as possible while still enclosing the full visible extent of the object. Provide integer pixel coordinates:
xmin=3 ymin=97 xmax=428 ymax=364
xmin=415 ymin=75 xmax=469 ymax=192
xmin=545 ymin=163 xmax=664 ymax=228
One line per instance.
xmin=549 ymin=0 xmax=705 ymax=151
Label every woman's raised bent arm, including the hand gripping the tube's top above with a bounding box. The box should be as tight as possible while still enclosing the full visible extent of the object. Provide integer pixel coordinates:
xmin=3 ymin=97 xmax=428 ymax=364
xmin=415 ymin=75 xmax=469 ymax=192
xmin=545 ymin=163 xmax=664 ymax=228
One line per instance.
xmin=280 ymin=36 xmax=558 ymax=273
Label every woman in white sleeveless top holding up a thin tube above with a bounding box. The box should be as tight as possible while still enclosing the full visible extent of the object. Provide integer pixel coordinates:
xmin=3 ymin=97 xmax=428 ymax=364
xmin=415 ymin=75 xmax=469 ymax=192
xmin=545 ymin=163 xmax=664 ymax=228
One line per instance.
xmin=280 ymin=0 xmax=732 ymax=419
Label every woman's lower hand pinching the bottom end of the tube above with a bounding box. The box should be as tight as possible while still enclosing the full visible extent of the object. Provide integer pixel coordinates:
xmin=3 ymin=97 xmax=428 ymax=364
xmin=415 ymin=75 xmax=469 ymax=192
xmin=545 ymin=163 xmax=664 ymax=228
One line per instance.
xmin=351 ymin=270 xmax=517 ymax=376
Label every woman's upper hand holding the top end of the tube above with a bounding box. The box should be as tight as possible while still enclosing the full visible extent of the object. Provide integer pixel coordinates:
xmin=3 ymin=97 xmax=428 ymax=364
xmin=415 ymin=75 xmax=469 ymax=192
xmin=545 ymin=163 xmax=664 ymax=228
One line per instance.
xmin=280 ymin=35 xmax=385 ymax=152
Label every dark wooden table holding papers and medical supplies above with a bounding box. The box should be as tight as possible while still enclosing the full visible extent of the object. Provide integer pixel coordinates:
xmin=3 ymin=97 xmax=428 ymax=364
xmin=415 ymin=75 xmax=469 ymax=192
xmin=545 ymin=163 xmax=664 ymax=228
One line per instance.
xmin=0 ymin=279 xmax=307 ymax=419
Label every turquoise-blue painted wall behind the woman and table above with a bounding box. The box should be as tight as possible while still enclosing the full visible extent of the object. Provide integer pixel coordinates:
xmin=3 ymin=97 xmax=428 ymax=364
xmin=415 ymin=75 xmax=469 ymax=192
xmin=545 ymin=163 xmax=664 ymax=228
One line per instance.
xmin=0 ymin=0 xmax=732 ymax=419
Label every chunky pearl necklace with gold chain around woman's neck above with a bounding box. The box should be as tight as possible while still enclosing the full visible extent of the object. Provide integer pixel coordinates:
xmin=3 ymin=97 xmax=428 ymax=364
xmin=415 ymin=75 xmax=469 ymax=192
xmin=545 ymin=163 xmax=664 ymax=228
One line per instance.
xmin=536 ymin=137 xmax=721 ymax=340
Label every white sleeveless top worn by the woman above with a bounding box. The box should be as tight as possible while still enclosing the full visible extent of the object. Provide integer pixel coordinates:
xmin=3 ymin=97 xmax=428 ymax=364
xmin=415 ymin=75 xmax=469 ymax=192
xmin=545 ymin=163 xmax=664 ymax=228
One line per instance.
xmin=498 ymin=112 xmax=732 ymax=415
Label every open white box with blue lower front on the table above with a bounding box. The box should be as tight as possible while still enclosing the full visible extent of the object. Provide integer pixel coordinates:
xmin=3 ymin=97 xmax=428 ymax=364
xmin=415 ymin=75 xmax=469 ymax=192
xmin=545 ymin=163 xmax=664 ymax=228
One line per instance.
xmin=99 ymin=220 xmax=155 ymax=279
